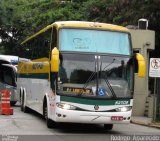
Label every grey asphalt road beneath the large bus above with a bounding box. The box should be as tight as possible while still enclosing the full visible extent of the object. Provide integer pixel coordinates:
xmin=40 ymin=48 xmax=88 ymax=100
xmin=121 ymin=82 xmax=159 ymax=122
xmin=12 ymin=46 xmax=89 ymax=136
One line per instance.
xmin=0 ymin=106 xmax=160 ymax=141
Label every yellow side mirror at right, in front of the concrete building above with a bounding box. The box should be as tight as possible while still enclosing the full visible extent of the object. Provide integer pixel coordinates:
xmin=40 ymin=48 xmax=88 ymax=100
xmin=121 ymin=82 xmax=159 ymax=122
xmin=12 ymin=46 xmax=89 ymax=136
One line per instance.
xmin=135 ymin=53 xmax=146 ymax=77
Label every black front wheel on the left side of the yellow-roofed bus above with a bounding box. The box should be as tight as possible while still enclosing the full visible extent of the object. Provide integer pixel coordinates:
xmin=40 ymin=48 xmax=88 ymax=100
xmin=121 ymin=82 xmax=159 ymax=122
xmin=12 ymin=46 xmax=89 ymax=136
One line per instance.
xmin=43 ymin=102 xmax=53 ymax=128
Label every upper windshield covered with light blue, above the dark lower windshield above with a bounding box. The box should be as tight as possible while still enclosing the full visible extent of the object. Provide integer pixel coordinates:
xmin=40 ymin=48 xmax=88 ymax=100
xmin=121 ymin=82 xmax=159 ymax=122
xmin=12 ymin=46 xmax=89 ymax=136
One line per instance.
xmin=59 ymin=29 xmax=131 ymax=55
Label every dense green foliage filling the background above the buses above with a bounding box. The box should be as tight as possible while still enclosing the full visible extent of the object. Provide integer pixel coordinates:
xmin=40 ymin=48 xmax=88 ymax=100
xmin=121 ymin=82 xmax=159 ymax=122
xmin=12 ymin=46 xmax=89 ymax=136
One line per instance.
xmin=0 ymin=0 xmax=160 ymax=57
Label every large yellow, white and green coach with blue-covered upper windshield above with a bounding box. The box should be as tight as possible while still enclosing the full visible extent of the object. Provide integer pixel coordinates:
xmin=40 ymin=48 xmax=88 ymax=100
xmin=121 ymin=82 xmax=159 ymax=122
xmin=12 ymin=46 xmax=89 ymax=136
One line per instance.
xmin=17 ymin=21 xmax=145 ymax=130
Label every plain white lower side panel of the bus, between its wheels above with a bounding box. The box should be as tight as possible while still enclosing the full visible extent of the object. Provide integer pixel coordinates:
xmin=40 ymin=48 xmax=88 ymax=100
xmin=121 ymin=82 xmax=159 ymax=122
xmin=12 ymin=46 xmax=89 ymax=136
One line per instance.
xmin=17 ymin=78 xmax=50 ymax=114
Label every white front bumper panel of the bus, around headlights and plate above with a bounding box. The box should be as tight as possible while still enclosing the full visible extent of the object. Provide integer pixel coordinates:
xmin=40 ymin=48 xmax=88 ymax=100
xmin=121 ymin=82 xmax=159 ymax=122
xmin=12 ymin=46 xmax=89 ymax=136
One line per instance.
xmin=50 ymin=96 xmax=133 ymax=124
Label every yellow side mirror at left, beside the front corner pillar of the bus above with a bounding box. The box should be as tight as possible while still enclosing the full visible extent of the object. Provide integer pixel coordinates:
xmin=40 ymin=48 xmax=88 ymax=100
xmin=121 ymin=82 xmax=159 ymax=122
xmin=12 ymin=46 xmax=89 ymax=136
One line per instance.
xmin=51 ymin=47 xmax=59 ymax=72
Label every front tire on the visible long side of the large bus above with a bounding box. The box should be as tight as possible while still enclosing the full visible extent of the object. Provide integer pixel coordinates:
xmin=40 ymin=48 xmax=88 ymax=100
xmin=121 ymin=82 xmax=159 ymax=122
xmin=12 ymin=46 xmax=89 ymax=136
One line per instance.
xmin=43 ymin=99 xmax=56 ymax=128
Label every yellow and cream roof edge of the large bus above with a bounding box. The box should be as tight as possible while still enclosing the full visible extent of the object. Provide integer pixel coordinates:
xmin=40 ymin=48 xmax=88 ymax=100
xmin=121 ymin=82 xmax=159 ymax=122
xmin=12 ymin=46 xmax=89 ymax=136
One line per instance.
xmin=21 ymin=21 xmax=129 ymax=44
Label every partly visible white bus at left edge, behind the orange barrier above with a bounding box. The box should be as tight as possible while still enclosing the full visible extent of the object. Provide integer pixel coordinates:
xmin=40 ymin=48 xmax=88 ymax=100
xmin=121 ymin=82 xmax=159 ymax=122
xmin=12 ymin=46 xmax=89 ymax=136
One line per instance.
xmin=0 ymin=55 xmax=19 ymax=105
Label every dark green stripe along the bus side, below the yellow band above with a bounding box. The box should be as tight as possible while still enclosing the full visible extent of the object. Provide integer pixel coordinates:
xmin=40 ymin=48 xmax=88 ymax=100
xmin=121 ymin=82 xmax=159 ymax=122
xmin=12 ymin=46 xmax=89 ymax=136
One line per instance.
xmin=18 ymin=73 xmax=49 ymax=79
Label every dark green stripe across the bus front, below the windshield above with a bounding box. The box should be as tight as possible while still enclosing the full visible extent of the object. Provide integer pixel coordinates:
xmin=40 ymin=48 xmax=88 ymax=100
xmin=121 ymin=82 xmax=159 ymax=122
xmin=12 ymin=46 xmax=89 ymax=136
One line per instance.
xmin=60 ymin=96 xmax=130 ymax=105
